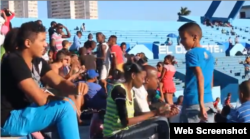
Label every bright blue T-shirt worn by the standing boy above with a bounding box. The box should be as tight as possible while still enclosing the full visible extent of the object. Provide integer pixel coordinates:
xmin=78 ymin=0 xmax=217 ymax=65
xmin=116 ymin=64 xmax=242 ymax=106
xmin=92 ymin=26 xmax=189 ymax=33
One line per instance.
xmin=183 ymin=47 xmax=214 ymax=106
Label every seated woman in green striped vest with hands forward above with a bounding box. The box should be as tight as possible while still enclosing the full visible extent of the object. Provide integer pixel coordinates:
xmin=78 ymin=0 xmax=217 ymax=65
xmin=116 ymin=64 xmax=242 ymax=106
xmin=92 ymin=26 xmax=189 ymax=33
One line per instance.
xmin=103 ymin=63 xmax=176 ymax=139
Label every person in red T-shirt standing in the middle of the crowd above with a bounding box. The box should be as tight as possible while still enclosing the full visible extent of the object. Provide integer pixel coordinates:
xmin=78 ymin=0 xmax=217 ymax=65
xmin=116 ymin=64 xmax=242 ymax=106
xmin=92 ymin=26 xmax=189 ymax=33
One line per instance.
xmin=108 ymin=35 xmax=124 ymax=72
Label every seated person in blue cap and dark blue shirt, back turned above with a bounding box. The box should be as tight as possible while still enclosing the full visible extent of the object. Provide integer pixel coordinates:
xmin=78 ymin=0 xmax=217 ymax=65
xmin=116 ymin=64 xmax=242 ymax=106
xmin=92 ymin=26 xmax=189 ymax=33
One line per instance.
xmin=85 ymin=69 xmax=107 ymax=110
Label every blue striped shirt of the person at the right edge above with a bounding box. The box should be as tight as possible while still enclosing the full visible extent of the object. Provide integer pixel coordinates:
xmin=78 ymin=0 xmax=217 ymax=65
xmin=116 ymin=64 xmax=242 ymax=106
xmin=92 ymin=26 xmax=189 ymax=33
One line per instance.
xmin=230 ymin=101 xmax=250 ymax=123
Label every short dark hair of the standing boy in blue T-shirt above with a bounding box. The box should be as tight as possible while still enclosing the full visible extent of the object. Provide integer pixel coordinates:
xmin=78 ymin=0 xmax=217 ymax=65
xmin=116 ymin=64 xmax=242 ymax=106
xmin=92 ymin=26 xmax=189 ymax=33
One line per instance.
xmin=178 ymin=22 xmax=202 ymax=39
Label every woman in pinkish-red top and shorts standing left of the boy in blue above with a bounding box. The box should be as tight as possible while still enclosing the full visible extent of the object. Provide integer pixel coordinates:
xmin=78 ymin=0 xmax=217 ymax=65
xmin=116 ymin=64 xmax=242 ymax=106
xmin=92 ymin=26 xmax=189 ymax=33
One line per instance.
xmin=160 ymin=55 xmax=176 ymax=104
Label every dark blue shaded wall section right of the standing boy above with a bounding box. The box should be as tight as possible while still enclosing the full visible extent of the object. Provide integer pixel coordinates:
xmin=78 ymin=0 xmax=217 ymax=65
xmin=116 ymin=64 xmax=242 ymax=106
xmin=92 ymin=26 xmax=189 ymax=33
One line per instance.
xmin=214 ymin=70 xmax=239 ymax=102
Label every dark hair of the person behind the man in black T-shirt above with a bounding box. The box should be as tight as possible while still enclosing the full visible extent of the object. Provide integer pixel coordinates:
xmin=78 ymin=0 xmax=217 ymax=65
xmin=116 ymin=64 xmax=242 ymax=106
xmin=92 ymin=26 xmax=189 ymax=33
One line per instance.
xmin=3 ymin=28 xmax=19 ymax=52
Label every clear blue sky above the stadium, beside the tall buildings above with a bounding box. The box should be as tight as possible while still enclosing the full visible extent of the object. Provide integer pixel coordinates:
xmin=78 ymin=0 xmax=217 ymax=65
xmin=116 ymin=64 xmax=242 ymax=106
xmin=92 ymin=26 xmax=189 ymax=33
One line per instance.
xmin=38 ymin=1 xmax=250 ymax=21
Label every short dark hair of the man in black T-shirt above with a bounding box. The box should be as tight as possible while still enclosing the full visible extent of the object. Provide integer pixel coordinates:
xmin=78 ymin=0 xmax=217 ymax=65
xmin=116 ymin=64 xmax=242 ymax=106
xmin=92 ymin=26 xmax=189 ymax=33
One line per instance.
xmin=17 ymin=21 xmax=46 ymax=49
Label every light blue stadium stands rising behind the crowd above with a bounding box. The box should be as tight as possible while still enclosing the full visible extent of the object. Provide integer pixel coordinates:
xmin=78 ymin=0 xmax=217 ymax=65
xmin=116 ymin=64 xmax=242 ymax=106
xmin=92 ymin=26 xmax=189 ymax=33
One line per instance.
xmin=9 ymin=16 xmax=250 ymax=106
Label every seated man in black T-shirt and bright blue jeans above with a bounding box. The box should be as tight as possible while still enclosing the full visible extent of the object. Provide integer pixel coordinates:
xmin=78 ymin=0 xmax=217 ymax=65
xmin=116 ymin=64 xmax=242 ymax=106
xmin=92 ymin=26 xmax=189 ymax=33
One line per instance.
xmin=0 ymin=22 xmax=87 ymax=139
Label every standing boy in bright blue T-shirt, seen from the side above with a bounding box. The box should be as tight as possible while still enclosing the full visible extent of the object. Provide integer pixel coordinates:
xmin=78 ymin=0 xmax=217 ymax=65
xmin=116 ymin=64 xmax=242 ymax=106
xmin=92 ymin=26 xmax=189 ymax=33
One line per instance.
xmin=179 ymin=22 xmax=216 ymax=123
